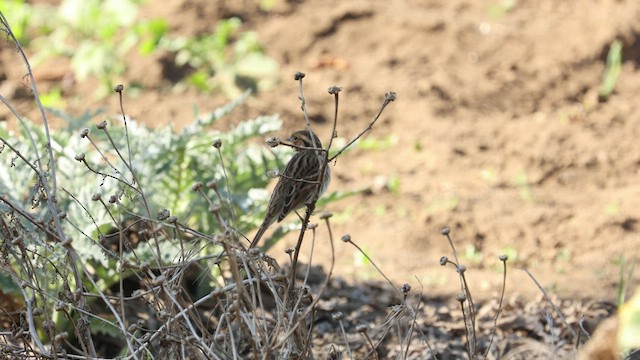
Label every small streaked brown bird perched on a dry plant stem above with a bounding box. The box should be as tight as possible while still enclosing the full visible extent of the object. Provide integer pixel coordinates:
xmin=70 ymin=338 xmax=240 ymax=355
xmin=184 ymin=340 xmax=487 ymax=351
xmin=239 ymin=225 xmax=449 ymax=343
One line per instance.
xmin=249 ymin=129 xmax=331 ymax=248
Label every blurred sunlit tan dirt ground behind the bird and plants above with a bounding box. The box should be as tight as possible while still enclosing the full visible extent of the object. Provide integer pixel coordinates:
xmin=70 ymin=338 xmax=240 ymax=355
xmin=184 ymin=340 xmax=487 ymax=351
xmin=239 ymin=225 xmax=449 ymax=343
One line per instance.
xmin=0 ymin=0 xmax=640 ymax=300
